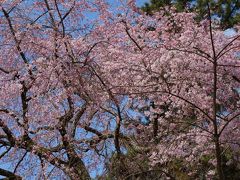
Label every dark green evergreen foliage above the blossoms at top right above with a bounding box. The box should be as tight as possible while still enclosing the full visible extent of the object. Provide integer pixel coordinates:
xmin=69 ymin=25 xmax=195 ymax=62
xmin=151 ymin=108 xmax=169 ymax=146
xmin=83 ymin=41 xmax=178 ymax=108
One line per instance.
xmin=142 ymin=0 xmax=240 ymax=29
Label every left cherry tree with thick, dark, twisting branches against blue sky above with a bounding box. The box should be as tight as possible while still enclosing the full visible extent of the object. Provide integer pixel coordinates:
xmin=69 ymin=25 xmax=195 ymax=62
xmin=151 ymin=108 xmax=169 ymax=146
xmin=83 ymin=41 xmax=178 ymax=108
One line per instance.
xmin=0 ymin=0 xmax=124 ymax=179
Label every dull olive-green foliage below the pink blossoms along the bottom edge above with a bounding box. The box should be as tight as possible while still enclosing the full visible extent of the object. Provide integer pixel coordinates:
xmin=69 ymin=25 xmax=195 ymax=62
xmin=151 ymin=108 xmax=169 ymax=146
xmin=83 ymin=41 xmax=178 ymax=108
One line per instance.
xmin=101 ymin=143 xmax=240 ymax=180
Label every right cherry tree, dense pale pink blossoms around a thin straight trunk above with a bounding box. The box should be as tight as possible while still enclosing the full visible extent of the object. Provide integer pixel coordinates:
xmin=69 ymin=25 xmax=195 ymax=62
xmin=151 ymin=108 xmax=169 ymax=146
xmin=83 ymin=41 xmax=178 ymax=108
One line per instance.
xmin=90 ymin=3 xmax=240 ymax=179
